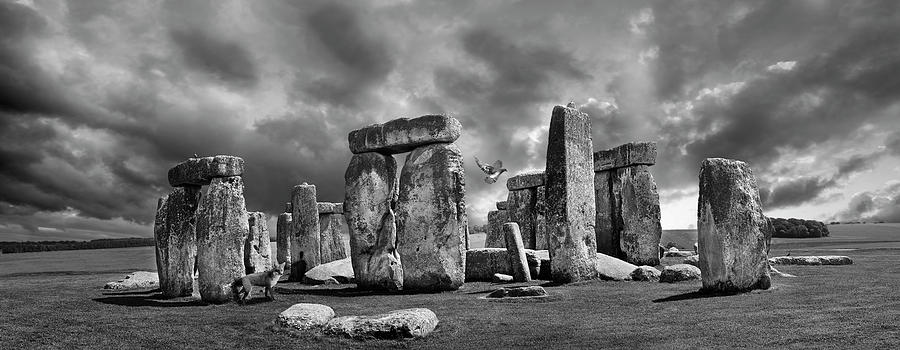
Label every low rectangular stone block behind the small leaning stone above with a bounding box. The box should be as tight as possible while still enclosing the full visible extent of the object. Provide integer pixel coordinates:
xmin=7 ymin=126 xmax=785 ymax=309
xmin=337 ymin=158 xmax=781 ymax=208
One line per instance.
xmin=466 ymin=248 xmax=550 ymax=281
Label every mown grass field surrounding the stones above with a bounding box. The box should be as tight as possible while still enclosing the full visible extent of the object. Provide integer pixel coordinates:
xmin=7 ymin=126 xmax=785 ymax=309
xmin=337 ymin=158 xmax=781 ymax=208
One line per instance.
xmin=0 ymin=225 xmax=900 ymax=349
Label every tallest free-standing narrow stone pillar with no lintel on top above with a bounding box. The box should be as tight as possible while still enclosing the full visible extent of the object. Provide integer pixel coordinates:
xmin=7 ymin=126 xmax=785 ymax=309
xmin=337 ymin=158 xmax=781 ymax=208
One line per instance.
xmin=546 ymin=106 xmax=600 ymax=282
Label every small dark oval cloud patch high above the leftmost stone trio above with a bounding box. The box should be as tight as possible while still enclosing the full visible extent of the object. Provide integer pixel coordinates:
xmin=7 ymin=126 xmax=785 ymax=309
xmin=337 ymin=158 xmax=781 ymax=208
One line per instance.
xmin=171 ymin=28 xmax=259 ymax=86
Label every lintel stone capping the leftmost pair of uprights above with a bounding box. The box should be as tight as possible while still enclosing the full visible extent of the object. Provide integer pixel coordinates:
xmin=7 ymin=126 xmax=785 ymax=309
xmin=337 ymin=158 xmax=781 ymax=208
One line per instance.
xmin=169 ymin=155 xmax=244 ymax=187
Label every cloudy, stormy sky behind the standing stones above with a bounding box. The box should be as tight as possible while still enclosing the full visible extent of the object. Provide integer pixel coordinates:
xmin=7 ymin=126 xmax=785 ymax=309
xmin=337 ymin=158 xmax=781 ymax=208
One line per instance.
xmin=0 ymin=0 xmax=900 ymax=241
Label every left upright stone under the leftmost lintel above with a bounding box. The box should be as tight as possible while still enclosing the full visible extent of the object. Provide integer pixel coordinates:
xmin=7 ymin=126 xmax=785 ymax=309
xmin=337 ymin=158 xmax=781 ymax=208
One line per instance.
xmin=153 ymin=186 xmax=201 ymax=298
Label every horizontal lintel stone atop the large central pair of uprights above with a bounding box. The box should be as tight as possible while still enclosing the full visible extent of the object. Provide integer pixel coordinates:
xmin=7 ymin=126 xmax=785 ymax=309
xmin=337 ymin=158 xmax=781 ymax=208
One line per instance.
xmin=348 ymin=115 xmax=462 ymax=154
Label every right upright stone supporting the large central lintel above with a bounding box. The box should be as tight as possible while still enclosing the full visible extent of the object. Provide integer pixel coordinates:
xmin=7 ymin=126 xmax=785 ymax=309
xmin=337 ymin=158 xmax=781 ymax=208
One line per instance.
xmin=397 ymin=143 xmax=468 ymax=290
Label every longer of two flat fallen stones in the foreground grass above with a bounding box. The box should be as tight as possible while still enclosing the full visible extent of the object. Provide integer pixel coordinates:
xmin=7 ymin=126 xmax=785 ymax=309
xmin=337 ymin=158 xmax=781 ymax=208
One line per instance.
xmin=325 ymin=308 xmax=438 ymax=339
